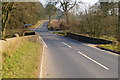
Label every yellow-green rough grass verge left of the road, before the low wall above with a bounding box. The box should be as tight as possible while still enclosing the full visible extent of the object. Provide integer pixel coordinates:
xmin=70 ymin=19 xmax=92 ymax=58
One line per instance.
xmin=2 ymin=36 xmax=42 ymax=78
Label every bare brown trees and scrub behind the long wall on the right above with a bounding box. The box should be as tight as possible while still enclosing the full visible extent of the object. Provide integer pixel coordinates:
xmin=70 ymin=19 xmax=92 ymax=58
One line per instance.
xmin=45 ymin=0 xmax=120 ymax=51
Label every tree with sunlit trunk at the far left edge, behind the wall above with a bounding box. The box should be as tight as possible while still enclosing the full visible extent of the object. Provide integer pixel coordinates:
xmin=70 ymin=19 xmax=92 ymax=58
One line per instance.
xmin=2 ymin=2 xmax=14 ymax=35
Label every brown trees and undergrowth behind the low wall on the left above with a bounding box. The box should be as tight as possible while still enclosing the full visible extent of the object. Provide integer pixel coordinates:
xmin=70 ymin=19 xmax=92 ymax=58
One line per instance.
xmin=1 ymin=2 xmax=46 ymax=38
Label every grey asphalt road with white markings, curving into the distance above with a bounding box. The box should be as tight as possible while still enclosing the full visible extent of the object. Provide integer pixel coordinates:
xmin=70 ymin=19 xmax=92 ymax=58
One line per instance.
xmin=35 ymin=22 xmax=118 ymax=78
